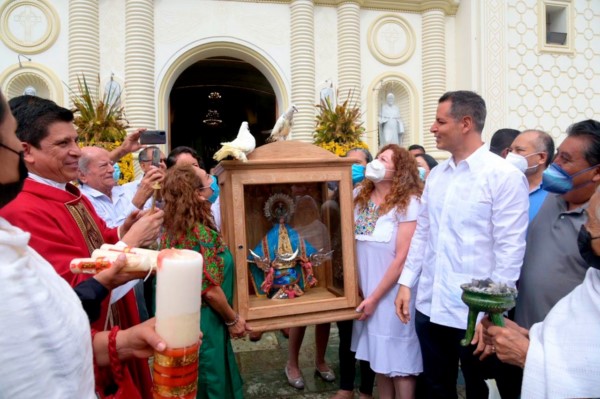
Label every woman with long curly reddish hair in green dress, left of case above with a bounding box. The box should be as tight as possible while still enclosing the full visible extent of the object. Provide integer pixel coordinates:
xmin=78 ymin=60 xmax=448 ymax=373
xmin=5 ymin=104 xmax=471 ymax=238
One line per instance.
xmin=161 ymin=165 xmax=250 ymax=399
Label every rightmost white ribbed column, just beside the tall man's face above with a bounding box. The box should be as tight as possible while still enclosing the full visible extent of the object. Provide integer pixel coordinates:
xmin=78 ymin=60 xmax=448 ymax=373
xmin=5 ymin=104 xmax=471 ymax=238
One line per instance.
xmin=422 ymin=8 xmax=446 ymax=153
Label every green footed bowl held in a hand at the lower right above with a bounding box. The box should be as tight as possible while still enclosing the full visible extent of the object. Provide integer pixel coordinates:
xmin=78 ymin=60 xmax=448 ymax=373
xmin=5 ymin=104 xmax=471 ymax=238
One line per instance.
xmin=460 ymin=279 xmax=517 ymax=346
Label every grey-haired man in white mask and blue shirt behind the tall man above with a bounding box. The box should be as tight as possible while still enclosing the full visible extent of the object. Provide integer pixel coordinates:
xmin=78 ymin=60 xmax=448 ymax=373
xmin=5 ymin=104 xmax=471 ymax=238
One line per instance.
xmin=506 ymin=129 xmax=554 ymax=223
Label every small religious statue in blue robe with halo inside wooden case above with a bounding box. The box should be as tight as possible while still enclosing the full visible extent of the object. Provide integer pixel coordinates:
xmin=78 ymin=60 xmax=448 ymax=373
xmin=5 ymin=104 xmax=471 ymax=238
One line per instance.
xmin=248 ymin=193 xmax=331 ymax=299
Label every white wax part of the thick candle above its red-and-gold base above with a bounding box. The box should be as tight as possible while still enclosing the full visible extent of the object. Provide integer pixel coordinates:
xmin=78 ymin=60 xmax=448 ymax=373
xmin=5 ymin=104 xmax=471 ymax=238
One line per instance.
xmin=156 ymin=249 xmax=203 ymax=348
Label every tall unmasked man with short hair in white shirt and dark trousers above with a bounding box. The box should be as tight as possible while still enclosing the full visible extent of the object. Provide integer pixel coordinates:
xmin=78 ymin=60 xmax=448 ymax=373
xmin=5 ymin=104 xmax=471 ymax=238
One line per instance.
xmin=396 ymin=91 xmax=529 ymax=398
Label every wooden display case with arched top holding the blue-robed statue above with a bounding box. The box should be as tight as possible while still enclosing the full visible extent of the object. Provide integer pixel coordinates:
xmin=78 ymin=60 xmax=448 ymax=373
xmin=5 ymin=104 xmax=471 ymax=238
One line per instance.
xmin=215 ymin=141 xmax=360 ymax=331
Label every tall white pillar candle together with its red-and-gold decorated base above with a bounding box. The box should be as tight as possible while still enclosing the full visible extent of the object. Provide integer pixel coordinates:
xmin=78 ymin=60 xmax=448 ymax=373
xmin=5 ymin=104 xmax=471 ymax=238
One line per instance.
xmin=153 ymin=249 xmax=203 ymax=399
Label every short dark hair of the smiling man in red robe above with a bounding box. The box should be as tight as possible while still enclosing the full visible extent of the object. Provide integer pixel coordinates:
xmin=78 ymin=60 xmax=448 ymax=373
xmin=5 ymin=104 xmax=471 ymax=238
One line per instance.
xmin=8 ymin=95 xmax=73 ymax=148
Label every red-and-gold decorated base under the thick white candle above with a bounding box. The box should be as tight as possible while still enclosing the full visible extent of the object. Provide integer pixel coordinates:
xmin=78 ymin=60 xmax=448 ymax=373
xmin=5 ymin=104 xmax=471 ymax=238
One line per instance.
xmin=152 ymin=343 xmax=200 ymax=399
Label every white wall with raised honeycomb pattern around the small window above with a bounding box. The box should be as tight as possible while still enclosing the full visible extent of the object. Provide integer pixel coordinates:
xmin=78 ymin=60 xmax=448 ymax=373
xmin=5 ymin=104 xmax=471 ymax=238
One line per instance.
xmin=507 ymin=0 xmax=600 ymax=144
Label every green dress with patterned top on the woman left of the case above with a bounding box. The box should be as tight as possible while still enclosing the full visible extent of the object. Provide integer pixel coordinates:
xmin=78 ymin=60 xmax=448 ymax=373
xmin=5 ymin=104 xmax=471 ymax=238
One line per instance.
xmin=161 ymin=223 xmax=243 ymax=399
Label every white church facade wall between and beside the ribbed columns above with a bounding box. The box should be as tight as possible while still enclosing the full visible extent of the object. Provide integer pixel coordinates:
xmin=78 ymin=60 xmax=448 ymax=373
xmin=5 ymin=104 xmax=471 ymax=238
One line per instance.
xmin=0 ymin=0 xmax=600 ymax=150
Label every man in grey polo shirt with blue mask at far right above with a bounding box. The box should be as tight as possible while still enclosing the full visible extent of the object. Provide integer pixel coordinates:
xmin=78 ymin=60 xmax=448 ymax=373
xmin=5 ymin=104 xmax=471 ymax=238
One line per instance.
xmin=502 ymin=120 xmax=600 ymax=396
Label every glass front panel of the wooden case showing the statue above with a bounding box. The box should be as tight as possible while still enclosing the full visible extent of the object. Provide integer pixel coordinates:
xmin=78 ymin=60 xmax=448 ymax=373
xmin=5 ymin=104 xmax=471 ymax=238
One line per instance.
xmin=243 ymin=181 xmax=344 ymax=307
